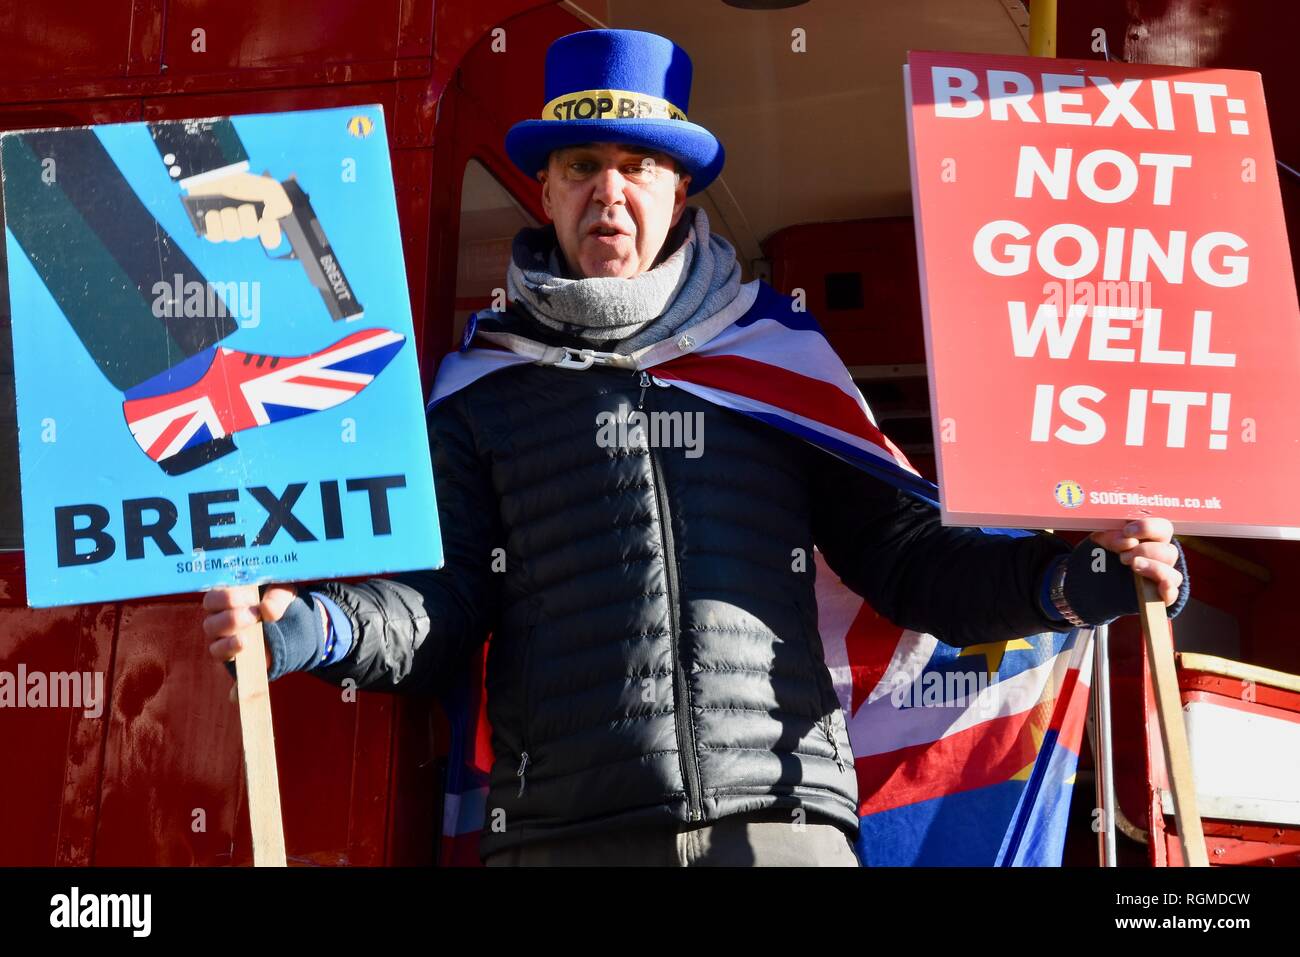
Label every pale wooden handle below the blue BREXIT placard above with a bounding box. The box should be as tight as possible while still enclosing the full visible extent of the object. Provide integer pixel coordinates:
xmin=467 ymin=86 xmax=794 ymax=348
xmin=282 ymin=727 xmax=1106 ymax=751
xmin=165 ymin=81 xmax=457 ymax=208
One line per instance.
xmin=234 ymin=585 xmax=285 ymax=867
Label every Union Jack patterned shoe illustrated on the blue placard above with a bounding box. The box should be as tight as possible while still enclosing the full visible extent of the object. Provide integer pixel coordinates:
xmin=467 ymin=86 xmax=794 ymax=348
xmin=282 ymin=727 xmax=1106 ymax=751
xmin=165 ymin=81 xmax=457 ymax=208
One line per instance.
xmin=122 ymin=329 xmax=406 ymax=475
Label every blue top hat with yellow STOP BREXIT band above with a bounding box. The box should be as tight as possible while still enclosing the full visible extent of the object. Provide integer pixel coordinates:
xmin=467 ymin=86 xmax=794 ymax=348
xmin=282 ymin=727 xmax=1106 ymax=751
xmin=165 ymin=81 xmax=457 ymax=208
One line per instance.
xmin=506 ymin=30 xmax=725 ymax=195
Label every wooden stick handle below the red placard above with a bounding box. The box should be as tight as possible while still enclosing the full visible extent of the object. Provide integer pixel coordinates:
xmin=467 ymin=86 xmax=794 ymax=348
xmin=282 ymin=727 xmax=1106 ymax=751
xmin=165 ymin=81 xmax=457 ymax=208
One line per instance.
xmin=1134 ymin=571 xmax=1209 ymax=867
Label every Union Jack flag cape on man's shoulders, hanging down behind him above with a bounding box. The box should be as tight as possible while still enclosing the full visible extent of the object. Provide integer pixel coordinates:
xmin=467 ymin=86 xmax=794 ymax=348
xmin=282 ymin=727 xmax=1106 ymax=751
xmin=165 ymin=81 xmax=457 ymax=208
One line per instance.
xmin=429 ymin=281 xmax=1092 ymax=866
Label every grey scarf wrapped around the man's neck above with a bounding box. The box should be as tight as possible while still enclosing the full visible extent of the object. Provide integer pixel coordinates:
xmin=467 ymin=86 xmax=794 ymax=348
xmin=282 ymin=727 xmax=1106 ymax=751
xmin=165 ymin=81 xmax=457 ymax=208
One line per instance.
xmin=506 ymin=207 xmax=741 ymax=355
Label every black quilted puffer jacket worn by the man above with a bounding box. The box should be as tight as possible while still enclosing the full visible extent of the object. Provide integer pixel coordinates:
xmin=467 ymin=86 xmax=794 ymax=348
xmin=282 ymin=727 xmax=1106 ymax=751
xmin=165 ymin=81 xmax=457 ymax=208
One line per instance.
xmin=306 ymin=302 xmax=1070 ymax=856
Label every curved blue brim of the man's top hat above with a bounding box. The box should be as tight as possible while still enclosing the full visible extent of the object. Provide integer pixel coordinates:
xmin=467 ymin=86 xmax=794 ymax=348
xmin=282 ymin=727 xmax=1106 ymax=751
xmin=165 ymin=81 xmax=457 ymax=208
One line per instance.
xmin=506 ymin=120 xmax=725 ymax=196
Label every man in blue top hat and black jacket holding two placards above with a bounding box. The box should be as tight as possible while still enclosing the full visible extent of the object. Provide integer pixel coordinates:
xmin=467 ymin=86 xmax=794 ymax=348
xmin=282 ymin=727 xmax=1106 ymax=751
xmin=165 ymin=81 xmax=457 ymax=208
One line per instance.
xmin=204 ymin=30 xmax=1187 ymax=866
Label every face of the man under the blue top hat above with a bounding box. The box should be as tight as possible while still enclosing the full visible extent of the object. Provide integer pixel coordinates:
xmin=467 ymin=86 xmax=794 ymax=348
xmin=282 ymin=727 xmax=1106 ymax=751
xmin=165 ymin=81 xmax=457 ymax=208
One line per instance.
xmin=537 ymin=143 xmax=690 ymax=280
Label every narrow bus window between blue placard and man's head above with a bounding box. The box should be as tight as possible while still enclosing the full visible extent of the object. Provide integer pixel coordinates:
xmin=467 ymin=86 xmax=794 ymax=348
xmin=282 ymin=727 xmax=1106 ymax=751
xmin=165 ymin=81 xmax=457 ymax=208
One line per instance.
xmin=450 ymin=160 xmax=538 ymax=347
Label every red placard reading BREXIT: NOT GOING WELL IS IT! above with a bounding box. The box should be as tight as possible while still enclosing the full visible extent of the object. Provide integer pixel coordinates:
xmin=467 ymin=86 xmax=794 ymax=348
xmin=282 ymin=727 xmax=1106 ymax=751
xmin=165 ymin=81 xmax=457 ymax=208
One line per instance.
xmin=905 ymin=52 xmax=1300 ymax=538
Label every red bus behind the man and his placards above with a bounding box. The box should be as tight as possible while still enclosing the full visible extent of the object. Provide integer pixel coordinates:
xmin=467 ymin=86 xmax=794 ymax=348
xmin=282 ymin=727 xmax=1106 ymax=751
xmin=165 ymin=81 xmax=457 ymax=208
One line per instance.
xmin=0 ymin=0 xmax=1300 ymax=866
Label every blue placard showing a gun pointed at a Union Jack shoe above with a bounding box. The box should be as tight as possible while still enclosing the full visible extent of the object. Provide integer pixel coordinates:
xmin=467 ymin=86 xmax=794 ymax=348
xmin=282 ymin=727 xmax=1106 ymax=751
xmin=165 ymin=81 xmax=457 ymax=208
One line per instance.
xmin=0 ymin=105 xmax=442 ymax=607
